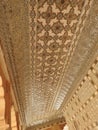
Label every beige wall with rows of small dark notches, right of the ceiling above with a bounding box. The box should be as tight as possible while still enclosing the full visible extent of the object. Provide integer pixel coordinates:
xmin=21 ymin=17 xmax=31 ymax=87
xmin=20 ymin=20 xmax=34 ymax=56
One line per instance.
xmin=64 ymin=57 xmax=98 ymax=130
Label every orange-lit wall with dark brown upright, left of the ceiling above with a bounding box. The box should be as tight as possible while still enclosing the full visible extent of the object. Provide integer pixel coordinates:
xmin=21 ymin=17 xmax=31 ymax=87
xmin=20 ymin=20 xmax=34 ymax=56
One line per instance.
xmin=0 ymin=46 xmax=21 ymax=130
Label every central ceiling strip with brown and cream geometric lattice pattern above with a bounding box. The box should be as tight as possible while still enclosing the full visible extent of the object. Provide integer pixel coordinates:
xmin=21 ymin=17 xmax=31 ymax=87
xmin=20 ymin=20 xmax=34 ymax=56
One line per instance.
xmin=30 ymin=0 xmax=90 ymax=124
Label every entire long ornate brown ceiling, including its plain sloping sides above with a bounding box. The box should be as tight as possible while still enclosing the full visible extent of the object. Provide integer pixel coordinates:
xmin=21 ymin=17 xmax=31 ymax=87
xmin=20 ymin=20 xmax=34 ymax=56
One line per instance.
xmin=0 ymin=0 xmax=98 ymax=127
